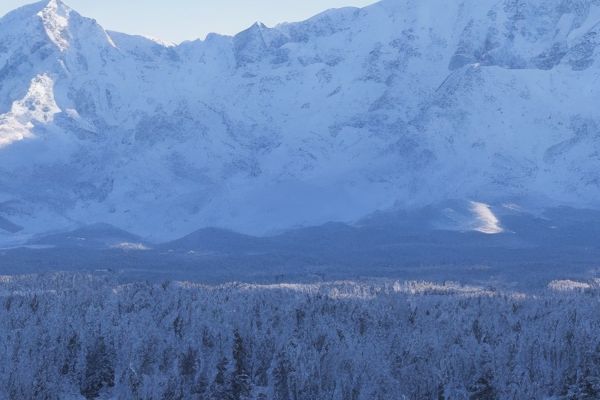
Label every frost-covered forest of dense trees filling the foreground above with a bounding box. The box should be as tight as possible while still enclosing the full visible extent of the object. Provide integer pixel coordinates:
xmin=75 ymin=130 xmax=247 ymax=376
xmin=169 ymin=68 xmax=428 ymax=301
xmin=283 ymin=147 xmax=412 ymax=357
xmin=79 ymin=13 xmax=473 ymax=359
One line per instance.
xmin=0 ymin=274 xmax=600 ymax=400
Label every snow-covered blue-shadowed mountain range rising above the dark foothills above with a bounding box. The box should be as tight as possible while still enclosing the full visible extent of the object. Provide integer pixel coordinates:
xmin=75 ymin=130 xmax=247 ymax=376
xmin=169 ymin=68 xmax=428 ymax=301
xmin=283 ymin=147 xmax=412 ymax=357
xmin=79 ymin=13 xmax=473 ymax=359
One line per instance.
xmin=0 ymin=0 xmax=600 ymax=242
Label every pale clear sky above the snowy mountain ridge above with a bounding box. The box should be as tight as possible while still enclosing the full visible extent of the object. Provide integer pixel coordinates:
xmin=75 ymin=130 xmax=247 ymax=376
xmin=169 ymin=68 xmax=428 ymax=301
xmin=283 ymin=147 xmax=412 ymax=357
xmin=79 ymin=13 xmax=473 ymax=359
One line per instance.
xmin=0 ymin=0 xmax=375 ymax=42
